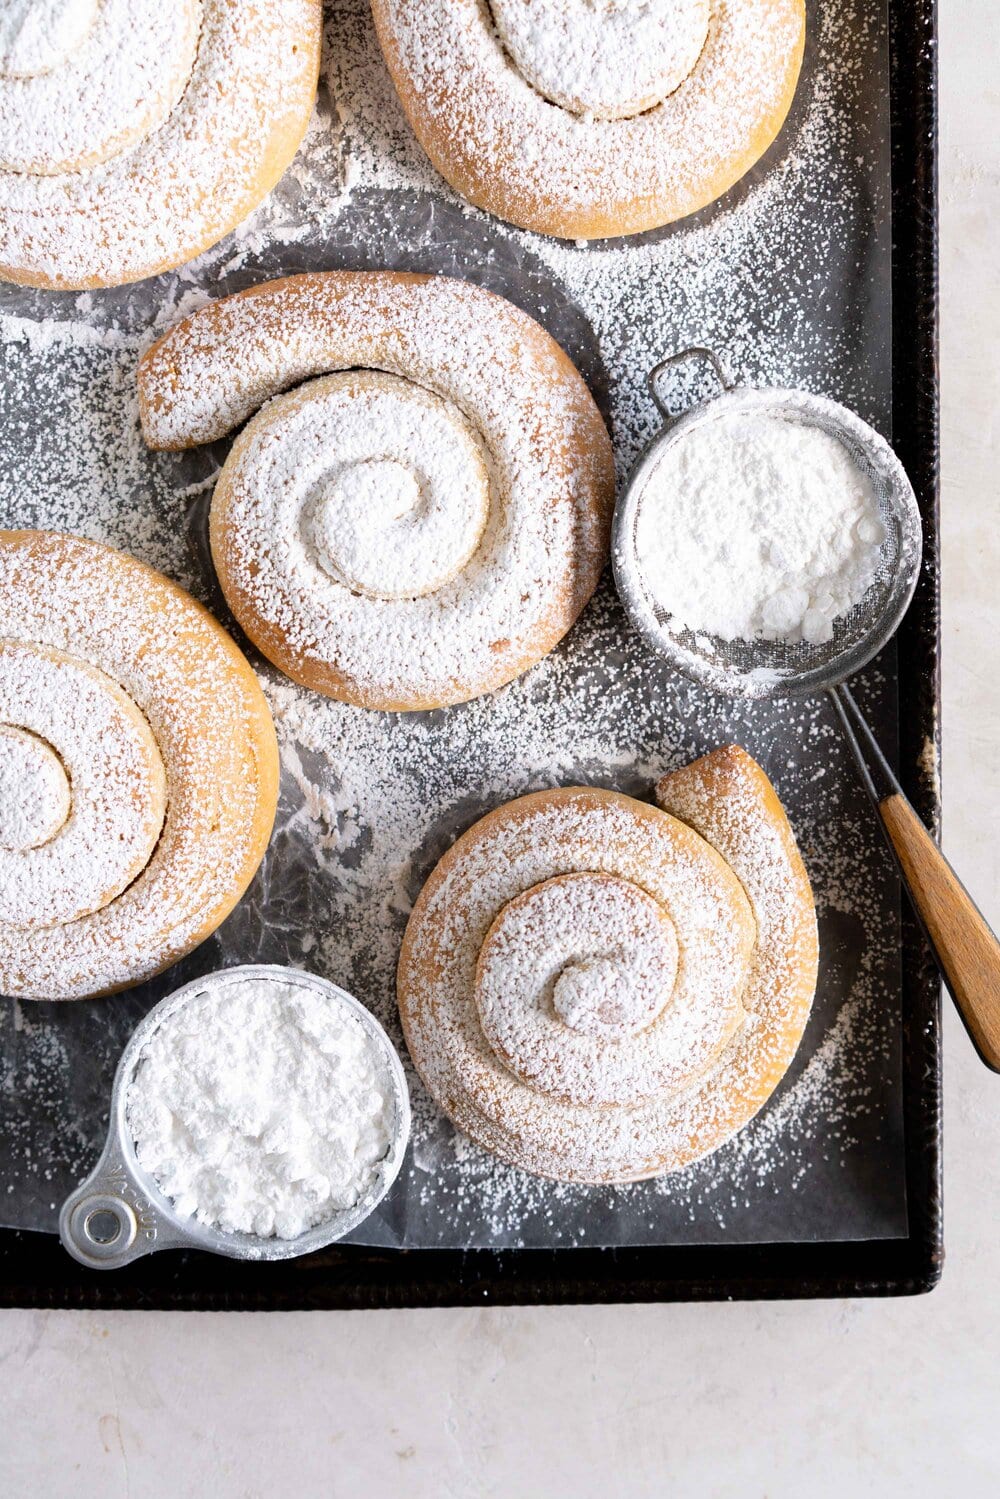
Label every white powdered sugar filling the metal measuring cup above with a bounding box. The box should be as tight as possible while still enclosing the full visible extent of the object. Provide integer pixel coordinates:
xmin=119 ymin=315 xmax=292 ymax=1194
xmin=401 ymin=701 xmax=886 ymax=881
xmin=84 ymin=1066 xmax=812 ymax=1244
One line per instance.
xmin=126 ymin=976 xmax=396 ymax=1238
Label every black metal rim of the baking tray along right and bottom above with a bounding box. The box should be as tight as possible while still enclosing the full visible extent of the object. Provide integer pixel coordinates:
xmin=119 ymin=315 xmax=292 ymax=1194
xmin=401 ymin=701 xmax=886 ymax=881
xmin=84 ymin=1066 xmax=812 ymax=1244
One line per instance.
xmin=0 ymin=0 xmax=942 ymax=1310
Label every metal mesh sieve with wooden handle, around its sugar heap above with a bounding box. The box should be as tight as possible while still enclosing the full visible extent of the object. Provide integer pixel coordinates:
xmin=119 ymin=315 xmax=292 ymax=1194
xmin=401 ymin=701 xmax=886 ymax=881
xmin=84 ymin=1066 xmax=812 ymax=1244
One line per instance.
xmin=612 ymin=348 xmax=1000 ymax=1072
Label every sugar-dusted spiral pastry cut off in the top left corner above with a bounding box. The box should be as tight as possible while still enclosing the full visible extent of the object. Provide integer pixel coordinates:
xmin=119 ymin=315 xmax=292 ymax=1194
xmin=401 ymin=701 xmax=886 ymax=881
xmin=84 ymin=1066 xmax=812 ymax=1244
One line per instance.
xmin=0 ymin=0 xmax=322 ymax=288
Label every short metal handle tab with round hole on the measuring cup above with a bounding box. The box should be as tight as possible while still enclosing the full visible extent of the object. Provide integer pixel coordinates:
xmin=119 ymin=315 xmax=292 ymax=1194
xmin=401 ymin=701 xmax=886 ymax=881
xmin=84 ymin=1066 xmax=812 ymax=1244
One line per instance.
xmin=58 ymin=1142 xmax=184 ymax=1270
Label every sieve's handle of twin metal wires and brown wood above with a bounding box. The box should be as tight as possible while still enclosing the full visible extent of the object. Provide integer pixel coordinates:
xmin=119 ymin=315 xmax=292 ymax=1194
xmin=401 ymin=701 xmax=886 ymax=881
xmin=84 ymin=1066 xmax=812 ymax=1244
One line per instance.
xmin=829 ymin=685 xmax=1000 ymax=1072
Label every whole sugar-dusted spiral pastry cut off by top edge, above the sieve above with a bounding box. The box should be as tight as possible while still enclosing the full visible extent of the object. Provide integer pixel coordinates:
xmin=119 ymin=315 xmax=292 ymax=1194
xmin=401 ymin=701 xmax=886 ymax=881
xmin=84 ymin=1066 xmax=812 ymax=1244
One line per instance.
xmin=372 ymin=0 xmax=805 ymax=238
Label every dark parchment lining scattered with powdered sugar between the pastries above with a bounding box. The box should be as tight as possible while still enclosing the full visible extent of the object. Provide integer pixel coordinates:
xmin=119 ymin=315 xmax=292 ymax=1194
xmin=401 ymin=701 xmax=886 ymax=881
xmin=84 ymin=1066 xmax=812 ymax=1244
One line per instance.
xmin=0 ymin=0 xmax=911 ymax=1246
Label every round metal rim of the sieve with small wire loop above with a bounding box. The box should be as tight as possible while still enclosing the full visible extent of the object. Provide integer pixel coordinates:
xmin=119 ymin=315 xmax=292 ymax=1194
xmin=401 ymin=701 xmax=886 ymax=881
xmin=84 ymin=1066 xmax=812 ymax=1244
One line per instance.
xmin=612 ymin=374 xmax=922 ymax=700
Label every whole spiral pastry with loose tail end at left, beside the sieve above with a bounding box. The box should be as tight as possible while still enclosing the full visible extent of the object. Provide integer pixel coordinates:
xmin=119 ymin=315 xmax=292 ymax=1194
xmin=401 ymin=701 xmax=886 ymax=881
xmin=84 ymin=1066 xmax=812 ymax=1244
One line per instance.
xmin=139 ymin=271 xmax=615 ymax=709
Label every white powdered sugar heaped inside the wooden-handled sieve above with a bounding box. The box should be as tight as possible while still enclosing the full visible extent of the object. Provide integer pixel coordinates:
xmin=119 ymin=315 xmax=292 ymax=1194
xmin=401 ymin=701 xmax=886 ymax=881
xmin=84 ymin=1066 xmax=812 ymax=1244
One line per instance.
xmin=636 ymin=411 xmax=886 ymax=645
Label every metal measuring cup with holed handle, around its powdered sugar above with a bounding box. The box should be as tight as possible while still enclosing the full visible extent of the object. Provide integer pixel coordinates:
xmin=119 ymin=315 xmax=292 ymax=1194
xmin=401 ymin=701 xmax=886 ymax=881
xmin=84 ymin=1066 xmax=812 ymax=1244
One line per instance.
xmin=58 ymin=964 xmax=409 ymax=1270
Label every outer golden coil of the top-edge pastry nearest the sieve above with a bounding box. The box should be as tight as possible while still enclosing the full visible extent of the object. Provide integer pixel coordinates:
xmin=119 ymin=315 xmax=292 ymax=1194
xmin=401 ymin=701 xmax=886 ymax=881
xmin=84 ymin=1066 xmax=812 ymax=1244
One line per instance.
xmin=372 ymin=0 xmax=805 ymax=240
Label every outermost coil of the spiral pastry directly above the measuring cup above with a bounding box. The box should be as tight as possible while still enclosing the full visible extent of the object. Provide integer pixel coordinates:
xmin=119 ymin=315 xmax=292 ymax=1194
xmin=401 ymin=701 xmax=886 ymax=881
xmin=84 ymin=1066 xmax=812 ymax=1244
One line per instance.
xmin=0 ymin=531 xmax=279 ymax=998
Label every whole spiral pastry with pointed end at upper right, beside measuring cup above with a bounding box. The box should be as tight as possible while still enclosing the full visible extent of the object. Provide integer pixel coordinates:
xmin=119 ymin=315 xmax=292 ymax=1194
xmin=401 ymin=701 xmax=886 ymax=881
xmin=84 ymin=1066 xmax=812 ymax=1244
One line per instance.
xmin=399 ymin=747 xmax=817 ymax=1183
